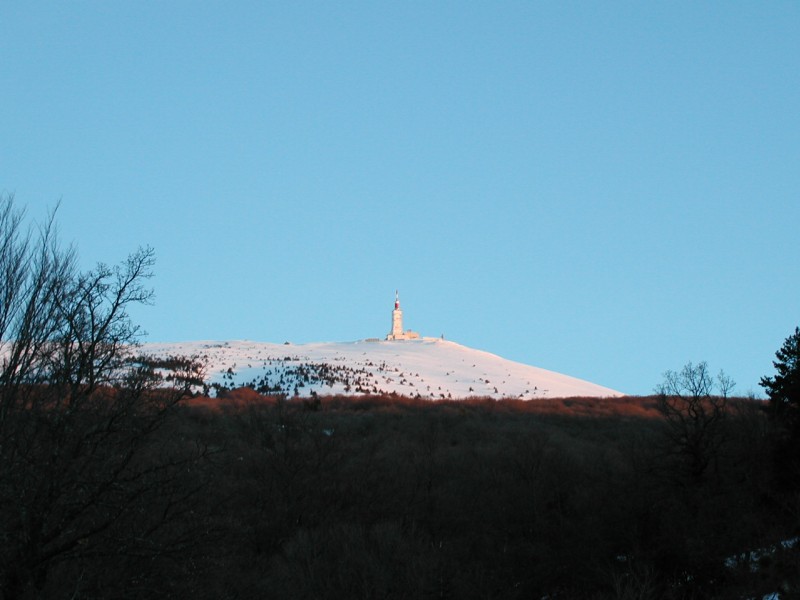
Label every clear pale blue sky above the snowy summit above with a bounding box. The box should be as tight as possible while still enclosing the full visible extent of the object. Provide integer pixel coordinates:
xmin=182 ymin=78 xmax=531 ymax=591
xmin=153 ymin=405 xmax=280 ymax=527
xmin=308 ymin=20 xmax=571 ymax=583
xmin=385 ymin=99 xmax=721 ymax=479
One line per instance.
xmin=0 ymin=0 xmax=800 ymax=394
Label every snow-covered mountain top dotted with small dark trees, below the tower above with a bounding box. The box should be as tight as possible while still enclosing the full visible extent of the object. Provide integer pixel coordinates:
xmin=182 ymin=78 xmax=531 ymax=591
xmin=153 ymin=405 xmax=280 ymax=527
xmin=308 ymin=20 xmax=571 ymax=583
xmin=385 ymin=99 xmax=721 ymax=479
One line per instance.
xmin=142 ymin=338 xmax=622 ymax=400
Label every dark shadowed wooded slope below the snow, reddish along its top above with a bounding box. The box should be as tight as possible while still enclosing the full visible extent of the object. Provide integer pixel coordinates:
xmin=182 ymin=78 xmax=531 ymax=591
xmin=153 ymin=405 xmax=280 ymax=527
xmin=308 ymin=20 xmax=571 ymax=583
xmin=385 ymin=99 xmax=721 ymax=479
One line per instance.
xmin=4 ymin=389 xmax=800 ymax=598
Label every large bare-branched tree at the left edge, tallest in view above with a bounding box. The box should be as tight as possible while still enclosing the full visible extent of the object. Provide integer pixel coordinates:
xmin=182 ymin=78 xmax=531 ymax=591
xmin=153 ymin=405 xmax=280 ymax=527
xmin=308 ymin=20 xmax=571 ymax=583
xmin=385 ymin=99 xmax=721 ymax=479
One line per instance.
xmin=0 ymin=197 xmax=205 ymax=598
